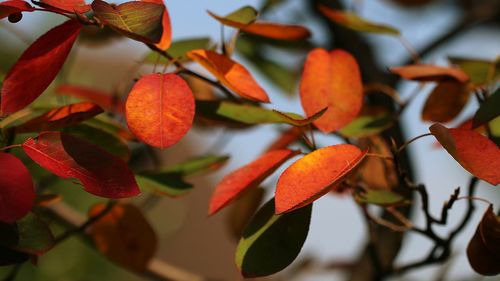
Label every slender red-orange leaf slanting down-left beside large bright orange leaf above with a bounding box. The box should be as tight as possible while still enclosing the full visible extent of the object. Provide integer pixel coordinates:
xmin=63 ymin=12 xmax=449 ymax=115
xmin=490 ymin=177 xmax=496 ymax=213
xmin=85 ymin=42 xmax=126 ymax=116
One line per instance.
xmin=208 ymin=149 xmax=299 ymax=215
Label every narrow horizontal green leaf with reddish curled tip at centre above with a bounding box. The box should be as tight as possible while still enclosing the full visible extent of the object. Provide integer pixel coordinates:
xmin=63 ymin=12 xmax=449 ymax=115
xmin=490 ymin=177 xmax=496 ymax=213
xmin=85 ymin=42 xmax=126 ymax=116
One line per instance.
xmin=217 ymin=102 xmax=327 ymax=126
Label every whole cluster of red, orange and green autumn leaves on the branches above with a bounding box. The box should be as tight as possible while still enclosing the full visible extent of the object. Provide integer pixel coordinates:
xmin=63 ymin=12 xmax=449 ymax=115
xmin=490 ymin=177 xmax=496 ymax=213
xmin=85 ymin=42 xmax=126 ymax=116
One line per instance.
xmin=0 ymin=0 xmax=500 ymax=277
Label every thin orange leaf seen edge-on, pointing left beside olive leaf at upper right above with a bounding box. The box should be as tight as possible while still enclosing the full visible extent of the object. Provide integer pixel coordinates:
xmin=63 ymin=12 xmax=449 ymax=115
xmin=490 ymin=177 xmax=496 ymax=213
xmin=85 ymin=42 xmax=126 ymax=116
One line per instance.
xmin=389 ymin=64 xmax=469 ymax=83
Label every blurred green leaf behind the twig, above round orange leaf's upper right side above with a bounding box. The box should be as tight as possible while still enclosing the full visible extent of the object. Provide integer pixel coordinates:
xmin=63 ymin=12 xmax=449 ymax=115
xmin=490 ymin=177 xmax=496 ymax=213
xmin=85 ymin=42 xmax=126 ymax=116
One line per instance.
xmin=144 ymin=37 xmax=214 ymax=64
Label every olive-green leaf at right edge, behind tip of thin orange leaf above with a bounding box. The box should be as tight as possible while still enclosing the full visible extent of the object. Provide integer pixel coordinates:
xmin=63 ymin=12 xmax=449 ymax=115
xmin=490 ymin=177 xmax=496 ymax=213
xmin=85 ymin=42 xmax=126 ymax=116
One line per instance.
xmin=448 ymin=57 xmax=500 ymax=85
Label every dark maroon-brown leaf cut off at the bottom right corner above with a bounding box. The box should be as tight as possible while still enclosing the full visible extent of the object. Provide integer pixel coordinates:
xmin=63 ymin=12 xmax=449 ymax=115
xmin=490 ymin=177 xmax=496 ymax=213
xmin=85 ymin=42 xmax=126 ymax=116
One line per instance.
xmin=467 ymin=205 xmax=500 ymax=276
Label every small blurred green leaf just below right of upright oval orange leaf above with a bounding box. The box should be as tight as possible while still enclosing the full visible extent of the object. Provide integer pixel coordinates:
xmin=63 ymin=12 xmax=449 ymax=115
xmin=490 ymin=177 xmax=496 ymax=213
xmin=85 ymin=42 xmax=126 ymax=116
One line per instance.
xmin=340 ymin=114 xmax=394 ymax=138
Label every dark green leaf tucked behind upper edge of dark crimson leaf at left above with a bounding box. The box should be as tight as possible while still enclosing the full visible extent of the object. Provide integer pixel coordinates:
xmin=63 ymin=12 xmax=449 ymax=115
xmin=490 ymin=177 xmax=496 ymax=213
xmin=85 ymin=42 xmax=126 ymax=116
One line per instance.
xmin=63 ymin=124 xmax=130 ymax=162
